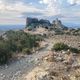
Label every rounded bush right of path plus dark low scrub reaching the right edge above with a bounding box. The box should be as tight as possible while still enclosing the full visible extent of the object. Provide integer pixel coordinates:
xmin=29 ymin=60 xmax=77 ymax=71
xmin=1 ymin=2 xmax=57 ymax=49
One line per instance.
xmin=52 ymin=43 xmax=80 ymax=53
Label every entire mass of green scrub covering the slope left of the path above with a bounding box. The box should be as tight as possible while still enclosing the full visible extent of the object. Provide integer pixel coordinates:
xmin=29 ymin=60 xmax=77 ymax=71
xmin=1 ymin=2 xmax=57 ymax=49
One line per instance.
xmin=0 ymin=30 xmax=42 ymax=64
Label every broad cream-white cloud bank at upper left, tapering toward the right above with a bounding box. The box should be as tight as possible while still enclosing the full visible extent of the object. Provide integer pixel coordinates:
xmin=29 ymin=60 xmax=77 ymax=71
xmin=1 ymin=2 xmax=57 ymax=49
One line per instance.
xmin=0 ymin=0 xmax=42 ymax=18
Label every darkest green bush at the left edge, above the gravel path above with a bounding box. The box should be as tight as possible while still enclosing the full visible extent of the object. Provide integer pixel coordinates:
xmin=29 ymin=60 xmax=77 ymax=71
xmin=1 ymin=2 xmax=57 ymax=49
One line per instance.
xmin=0 ymin=42 xmax=12 ymax=64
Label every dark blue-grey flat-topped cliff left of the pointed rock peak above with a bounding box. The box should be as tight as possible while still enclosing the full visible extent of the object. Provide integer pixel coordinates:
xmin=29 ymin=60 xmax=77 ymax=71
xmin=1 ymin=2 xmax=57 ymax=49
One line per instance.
xmin=26 ymin=17 xmax=51 ymax=28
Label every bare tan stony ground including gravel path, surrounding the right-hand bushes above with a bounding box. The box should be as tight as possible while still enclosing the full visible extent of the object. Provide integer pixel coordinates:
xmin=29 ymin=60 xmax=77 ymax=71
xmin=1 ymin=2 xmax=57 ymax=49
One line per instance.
xmin=0 ymin=35 xmax=80 ymax=80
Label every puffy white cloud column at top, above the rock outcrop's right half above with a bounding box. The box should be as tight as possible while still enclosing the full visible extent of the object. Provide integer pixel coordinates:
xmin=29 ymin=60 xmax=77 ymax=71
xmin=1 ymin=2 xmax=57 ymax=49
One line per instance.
xmin=39 ymin=0 xmax=60 ymax=16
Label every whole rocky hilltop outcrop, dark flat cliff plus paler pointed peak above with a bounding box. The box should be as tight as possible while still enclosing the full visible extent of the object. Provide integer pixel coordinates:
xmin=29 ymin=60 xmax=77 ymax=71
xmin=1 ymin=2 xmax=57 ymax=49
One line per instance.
xmin=26 ymin=17 xmax=68 ymax=30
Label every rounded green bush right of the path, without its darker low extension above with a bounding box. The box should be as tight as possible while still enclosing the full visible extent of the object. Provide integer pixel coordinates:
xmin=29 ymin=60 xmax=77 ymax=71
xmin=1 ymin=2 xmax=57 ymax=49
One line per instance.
xmin=52 ymin=43 xmax=69 ymax=51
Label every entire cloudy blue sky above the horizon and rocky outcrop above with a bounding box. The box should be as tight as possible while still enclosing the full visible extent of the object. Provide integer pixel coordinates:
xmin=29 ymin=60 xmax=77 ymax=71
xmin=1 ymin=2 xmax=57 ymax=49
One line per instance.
xmin=0 ymin=0 xmax=80 ymax=24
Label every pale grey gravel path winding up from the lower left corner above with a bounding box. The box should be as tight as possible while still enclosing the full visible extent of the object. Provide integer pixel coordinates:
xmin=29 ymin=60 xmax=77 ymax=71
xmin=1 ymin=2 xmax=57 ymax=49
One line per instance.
xmin=0 ymin=40 xmax=51 ymax=80
